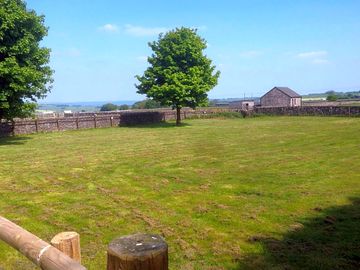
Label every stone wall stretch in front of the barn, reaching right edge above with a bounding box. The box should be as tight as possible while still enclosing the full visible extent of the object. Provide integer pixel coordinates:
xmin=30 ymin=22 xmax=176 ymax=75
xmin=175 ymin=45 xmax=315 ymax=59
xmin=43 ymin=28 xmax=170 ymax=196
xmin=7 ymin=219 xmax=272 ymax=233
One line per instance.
xmin=254 ymin=106 xmax=360 ymax=117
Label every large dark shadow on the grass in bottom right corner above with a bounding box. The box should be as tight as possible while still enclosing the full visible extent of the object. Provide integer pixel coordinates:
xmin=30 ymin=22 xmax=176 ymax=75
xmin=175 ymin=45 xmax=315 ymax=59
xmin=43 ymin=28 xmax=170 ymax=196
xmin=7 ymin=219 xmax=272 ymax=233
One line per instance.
xmin=237 ymin=198 xmax=360 ymax=270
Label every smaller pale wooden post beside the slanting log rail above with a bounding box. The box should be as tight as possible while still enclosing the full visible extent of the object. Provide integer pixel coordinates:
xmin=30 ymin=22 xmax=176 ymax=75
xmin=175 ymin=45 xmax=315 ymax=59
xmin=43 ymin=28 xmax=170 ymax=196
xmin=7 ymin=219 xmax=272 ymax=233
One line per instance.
xmin=50 ymin=232 xmax=81 ymax=263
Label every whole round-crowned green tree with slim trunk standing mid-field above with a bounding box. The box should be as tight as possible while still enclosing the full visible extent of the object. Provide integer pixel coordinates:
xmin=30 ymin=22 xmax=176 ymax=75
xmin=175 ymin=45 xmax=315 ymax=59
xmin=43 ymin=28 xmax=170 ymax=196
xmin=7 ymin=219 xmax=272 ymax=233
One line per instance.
xmin=135 ymin=27 xmax=220 ymax=125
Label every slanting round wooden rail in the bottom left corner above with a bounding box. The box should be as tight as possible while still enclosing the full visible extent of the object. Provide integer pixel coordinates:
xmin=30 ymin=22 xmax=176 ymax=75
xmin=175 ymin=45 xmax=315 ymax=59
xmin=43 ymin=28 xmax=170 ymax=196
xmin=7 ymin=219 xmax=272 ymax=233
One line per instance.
xmin=0 ymin=216 xmax=86 ymax=270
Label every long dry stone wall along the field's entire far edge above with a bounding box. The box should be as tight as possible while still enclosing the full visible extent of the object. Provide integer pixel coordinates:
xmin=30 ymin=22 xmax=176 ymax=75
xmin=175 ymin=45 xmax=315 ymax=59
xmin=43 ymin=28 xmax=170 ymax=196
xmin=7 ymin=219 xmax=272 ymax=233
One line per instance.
xmin=0 ymin=106 xmax=360 ymax=136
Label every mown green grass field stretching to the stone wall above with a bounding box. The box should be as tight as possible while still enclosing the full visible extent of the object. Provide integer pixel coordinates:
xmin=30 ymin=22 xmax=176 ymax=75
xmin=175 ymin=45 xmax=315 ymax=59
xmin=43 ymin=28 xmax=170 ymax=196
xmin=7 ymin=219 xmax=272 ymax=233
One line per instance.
xmin=0 ymin=117 xmax=360 ymax=270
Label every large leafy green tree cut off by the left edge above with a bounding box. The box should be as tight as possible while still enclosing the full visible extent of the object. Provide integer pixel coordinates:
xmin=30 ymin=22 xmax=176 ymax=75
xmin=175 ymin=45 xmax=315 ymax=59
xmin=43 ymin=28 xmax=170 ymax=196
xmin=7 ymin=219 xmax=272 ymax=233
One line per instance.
xmin=0 ymin=0 xmax=53 ymax=120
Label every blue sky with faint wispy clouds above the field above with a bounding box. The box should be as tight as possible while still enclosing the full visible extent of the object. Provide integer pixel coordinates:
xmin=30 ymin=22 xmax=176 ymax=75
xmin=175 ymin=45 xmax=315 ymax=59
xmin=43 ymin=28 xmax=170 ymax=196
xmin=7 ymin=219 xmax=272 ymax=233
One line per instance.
xmin=27 ymin=0 xmax=360 ymax=102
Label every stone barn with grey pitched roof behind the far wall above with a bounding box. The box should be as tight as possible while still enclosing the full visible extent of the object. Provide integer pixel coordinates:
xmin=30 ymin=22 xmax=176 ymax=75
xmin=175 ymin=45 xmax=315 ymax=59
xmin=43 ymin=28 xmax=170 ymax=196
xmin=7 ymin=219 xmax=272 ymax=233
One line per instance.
xmin=260 ymin=87 xmax=302 ymax=107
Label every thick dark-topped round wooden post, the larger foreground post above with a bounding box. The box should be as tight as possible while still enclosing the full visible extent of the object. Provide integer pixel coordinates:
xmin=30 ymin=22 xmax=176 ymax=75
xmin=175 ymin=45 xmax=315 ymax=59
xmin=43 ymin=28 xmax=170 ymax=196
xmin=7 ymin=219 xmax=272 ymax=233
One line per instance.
xmin=107 ymin=234 xmax=168 ymax=270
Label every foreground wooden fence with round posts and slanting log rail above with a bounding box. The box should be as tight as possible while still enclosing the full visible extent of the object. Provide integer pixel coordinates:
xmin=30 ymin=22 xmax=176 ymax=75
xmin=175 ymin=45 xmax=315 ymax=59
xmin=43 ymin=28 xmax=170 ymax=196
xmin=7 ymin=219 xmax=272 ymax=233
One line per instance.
xmin=0 ymin=216 xmax=168 ymax=270
